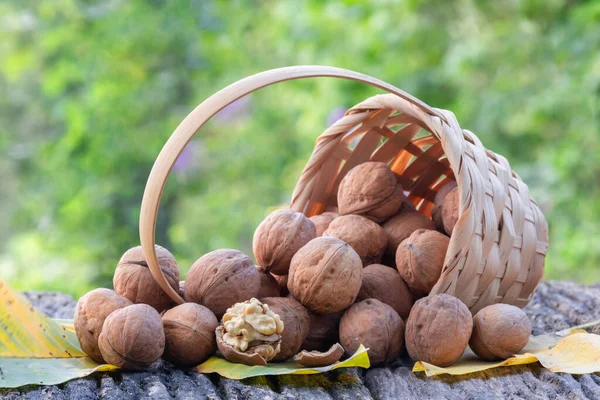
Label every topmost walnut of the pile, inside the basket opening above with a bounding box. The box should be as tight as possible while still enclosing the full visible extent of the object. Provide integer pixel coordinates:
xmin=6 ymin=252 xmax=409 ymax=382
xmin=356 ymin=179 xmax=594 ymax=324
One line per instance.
xmin=338 ymin=161 xmax=405 ymax=222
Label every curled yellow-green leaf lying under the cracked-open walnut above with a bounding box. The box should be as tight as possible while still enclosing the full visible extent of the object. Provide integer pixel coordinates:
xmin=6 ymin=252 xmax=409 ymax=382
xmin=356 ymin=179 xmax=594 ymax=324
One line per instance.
xmin=196 ymin=345 xmax=371 ymax=379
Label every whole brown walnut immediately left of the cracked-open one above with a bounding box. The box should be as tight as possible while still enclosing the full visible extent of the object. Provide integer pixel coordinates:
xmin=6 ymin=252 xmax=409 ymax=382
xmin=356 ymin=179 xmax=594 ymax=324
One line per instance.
xmin=162 ymin=303 xmax=219 ymax=367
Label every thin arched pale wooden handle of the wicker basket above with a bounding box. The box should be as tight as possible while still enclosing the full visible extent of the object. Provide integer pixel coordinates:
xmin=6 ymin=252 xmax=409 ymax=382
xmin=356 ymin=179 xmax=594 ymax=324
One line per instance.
xmin=140 ymin=65 xmax=446 ymax=304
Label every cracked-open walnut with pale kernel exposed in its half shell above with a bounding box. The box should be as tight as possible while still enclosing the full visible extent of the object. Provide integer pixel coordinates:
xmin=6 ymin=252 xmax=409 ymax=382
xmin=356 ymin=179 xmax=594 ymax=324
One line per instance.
xmin=216 ymin=298 xmax=285 ymax=365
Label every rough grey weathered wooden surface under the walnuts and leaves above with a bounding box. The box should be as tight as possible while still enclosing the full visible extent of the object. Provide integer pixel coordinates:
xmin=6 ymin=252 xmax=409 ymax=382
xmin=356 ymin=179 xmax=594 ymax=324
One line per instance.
xmin=0 ymin=281 xmax=600 ymax=400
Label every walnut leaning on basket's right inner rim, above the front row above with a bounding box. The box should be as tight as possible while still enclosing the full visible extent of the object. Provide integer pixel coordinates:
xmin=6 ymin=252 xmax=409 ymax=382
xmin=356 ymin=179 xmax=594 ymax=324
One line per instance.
xmin=396 ymin=229 xmax=450 ymax=296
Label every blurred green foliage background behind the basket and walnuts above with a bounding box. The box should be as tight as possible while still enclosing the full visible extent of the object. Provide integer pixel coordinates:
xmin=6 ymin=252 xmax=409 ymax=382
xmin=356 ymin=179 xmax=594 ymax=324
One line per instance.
xmin=0 ymin=0 xmax=600 ymax=295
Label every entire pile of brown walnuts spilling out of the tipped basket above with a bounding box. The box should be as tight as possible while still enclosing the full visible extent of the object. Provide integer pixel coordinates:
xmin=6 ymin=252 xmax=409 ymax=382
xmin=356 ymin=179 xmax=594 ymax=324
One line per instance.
xmin=75 ymin=162 xmax=531 ymax=369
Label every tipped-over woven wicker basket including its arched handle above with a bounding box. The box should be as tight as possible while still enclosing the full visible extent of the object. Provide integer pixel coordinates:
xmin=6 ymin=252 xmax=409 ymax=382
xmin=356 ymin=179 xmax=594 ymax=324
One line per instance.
xmin=140 ymin=66 xmax=548 ymax=313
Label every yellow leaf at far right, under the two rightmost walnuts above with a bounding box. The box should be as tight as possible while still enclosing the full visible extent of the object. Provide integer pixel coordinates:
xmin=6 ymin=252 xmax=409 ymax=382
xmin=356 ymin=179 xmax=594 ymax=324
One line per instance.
xmin=413 ymin=321 xmax=600 ymax=376
